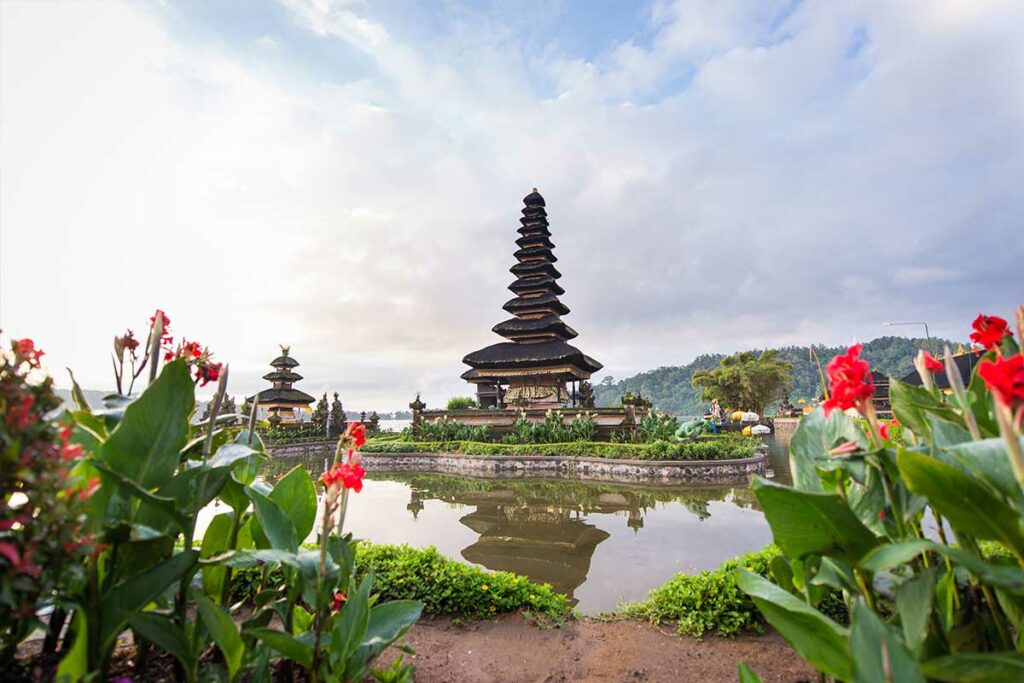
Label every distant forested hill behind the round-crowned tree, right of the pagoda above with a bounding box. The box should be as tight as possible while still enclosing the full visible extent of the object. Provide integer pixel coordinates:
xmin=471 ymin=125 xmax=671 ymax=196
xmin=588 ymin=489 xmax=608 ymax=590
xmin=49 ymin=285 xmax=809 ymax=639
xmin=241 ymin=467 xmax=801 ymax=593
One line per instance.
xmin=594 ymin=337 xmax=956 ymax=415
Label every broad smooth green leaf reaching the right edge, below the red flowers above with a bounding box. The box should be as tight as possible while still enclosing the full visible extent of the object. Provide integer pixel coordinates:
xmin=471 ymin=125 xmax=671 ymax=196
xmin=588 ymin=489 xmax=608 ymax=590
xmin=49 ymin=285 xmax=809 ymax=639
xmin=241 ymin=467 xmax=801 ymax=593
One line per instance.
xmin=897 ymin=449 xmax=1024 ymax=557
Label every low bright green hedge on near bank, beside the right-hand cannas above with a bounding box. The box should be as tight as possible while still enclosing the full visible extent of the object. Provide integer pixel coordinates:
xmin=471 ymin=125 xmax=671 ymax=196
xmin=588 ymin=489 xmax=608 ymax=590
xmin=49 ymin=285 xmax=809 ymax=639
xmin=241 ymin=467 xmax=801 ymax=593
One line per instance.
xmin=616 ymin=546 xmax=848 ymax=638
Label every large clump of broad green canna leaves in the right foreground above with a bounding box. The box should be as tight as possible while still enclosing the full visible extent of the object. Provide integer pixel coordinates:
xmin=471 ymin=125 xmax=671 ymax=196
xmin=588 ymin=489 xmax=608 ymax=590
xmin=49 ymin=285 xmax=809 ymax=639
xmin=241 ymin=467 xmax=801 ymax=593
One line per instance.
xmin=737 ymin=337 xmax=1024 ymax=683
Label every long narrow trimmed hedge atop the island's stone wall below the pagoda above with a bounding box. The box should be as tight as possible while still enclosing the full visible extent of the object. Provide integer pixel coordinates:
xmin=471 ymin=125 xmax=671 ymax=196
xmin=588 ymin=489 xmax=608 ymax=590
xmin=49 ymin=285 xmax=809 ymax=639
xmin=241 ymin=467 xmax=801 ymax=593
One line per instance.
xmin=360 ymin=436 xmax=761 ymax=460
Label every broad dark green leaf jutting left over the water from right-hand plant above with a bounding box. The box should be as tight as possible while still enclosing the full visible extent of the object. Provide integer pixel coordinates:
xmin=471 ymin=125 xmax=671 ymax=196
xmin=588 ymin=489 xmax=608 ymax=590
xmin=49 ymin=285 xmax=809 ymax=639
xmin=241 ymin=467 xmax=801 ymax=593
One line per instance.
xmin=754 ymin=477 xmax=878 ymax=564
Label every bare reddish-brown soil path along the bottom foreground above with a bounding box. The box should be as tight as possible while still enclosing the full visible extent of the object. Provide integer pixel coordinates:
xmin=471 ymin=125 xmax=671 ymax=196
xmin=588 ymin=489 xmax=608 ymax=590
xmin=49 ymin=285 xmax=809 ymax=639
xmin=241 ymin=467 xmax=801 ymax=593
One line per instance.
xmin=382 ymin=615 xmax=816 ymax=683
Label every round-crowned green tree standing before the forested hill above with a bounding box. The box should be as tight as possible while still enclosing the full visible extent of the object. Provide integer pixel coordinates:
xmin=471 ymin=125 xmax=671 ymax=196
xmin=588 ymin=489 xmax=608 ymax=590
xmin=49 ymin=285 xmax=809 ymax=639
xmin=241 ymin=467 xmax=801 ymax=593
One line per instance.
xmin=691 ymin=350 xmax=791 ymax=415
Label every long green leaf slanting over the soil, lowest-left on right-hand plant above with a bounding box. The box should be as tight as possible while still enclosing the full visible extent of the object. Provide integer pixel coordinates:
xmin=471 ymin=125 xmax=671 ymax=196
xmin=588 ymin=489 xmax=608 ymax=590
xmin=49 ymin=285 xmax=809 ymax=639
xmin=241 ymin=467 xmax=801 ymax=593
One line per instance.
xmin=736 ymin=569 xmax=852 ymax=680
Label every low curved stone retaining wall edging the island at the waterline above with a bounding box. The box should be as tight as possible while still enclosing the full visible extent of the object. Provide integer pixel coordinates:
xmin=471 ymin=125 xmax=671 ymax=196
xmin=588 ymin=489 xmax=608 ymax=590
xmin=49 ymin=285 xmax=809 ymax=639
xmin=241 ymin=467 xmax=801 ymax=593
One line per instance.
xmin=268 ymin=442 xmax=768 ymax=483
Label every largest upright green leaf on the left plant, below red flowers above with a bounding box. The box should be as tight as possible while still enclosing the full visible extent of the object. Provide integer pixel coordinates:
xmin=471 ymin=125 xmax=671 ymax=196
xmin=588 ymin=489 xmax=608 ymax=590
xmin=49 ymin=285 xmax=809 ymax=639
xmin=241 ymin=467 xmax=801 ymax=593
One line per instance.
xmin=100 ymin=360 xmax=196 ymax=488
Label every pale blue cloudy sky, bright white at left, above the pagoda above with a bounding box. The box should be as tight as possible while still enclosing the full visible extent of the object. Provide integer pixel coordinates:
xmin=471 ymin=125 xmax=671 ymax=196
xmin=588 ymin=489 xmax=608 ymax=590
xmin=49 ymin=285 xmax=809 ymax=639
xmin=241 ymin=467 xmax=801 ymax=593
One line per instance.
xmin=0 ymin=0 xmax=1024 ymax=410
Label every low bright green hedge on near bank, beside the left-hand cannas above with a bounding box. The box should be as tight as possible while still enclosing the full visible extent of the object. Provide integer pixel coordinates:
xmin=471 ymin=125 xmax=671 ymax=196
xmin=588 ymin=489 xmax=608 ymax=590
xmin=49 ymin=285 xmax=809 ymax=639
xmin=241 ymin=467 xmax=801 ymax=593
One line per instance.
xmin=231 ymin=542 xmax=572 ymax=622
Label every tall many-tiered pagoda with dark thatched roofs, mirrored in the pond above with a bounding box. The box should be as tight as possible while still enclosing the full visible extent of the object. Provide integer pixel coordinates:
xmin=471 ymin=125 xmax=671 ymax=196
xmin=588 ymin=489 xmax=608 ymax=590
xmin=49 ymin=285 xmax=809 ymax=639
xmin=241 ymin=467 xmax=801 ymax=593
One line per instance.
xmin=462 ymin=187 xmax=602 ymax=409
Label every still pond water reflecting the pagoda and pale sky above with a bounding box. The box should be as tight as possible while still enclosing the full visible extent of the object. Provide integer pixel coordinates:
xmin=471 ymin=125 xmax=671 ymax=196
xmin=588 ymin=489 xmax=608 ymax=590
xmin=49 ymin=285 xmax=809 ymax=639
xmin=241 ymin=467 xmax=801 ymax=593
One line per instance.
xmin=230 ymin=441 xmax=788 ymax=614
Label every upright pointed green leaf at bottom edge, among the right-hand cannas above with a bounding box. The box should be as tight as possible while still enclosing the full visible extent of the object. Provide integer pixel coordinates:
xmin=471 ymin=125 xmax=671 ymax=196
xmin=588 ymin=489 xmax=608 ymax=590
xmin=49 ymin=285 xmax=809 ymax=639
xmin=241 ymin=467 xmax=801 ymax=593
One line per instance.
xmin=850 ymin=600 xmax=925 ymax=683
